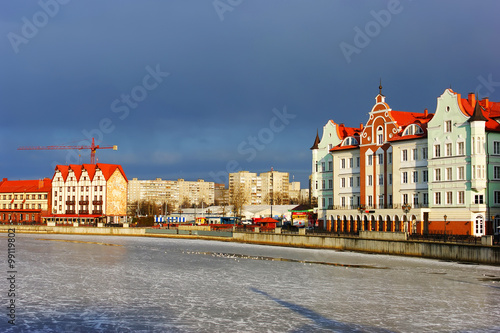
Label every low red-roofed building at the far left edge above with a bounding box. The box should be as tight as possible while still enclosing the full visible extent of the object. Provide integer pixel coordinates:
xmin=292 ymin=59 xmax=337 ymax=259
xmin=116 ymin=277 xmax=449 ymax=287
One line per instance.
xmin=0 ymin=178 xmax=51 ymax=224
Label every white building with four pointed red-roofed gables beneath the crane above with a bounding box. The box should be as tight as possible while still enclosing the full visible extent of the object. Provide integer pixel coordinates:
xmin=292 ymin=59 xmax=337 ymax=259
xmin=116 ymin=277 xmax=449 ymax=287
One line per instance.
xmin=46 ymin=163 xmax=128 ymax=224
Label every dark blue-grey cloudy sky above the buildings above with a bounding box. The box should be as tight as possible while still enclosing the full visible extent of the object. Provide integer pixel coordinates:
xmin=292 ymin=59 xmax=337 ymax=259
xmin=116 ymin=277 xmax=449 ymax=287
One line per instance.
xmin=0 ymin=0 xmax=500 ymax=188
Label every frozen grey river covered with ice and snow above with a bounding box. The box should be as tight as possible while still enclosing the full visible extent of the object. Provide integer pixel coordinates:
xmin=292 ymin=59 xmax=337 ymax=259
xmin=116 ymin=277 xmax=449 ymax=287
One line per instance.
xmin=0 ymin=234 xmax=500 ymax=332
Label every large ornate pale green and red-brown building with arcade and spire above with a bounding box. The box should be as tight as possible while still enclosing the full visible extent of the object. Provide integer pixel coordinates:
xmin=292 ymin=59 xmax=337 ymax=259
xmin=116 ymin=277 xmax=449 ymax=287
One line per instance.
xmin=311 ymin=87 xmax=500 ymax=236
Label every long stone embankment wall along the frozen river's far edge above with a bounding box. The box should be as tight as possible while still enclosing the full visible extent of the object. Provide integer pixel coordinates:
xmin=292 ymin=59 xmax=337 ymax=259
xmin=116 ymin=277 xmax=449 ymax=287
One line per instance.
xmin=0 ymin=225 xmax=500 ymax=265
